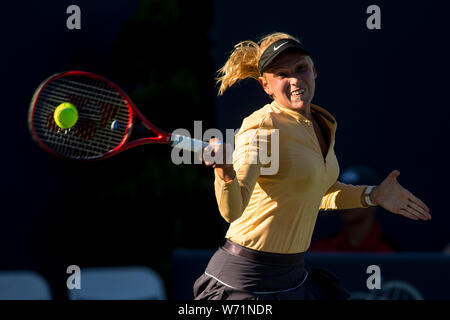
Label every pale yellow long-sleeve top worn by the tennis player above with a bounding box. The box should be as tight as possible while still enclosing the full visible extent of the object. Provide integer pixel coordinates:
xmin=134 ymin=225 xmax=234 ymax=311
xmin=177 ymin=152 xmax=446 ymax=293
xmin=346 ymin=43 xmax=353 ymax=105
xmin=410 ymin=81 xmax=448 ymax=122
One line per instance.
xmin=214 ymin=101 xmax=367 ymax=253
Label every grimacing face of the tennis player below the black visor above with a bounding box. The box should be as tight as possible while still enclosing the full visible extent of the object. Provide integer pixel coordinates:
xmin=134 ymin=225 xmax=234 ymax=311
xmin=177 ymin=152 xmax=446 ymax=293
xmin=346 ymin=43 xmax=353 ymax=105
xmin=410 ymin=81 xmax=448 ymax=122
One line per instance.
xmin=259 ymin=50 xmax=317 ymax=113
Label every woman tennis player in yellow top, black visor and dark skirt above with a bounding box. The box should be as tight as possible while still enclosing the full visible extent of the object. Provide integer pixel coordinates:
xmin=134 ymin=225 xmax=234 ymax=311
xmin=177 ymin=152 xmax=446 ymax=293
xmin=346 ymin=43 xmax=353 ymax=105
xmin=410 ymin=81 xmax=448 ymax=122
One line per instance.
xmin=194 ymin=33 xmax=431 ymax=300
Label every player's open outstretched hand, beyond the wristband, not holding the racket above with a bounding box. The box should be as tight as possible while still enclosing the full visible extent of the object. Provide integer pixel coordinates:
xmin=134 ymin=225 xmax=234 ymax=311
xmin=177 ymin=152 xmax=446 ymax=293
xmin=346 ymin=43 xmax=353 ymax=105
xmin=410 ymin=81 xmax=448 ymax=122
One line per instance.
xmin=370 ymin=170 xmax=431 ymax=221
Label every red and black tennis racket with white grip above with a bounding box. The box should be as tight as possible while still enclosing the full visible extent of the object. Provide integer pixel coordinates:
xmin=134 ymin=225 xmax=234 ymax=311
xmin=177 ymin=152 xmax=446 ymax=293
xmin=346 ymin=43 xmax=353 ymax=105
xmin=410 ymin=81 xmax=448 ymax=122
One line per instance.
xmin=28 ymin=71 xmax=208 ymax=160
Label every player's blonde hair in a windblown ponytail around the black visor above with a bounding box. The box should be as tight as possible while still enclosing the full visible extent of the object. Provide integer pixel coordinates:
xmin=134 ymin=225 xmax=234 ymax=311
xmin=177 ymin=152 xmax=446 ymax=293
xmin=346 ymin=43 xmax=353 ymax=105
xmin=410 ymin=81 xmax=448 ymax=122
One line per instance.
xmin=216 ymin=32 xmax=300 ymax=96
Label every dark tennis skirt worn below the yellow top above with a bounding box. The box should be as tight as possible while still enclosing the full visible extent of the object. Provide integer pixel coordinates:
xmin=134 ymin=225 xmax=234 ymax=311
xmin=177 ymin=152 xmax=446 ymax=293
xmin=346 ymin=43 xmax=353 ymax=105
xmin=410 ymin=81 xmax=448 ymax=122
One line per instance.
xmin=194 ymin=240 xmax=350 ymax=300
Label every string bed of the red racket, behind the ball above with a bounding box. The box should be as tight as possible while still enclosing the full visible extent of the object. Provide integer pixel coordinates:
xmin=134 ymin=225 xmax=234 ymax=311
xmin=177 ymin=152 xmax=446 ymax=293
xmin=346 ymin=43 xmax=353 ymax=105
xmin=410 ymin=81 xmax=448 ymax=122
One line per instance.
xmin=33 ymin=76 xmax=131 ymax=159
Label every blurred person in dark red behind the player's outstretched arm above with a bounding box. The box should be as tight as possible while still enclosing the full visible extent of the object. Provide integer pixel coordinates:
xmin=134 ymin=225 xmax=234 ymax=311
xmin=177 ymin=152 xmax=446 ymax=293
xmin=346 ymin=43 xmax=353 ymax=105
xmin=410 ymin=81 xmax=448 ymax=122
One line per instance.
xmin=310 ymin=166 xmax=398 ymax=252
